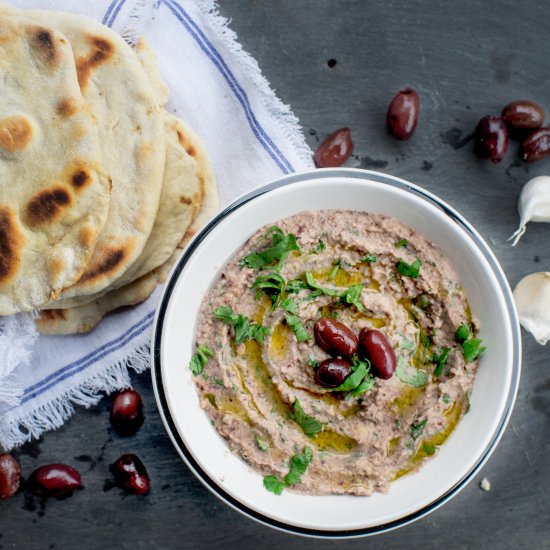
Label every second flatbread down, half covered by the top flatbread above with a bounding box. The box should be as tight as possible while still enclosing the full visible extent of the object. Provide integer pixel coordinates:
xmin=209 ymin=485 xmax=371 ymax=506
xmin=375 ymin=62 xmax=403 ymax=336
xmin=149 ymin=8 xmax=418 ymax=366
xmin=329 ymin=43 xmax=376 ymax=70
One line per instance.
xmin=5 ymin=10 xmax=166 ymax=298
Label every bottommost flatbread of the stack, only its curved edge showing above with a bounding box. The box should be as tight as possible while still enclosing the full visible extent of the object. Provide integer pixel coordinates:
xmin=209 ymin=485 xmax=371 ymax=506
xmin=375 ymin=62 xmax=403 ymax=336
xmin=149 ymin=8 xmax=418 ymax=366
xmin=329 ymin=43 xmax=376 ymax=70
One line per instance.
xmin=36 ymin=121 xmax=219 ymax=335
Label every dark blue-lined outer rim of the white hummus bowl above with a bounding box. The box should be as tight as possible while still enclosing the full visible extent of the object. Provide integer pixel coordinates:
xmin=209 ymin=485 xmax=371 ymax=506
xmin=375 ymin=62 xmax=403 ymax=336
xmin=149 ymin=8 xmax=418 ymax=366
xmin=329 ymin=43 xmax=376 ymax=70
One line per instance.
xmin=151 ymin=168 xmax=521 ymax=539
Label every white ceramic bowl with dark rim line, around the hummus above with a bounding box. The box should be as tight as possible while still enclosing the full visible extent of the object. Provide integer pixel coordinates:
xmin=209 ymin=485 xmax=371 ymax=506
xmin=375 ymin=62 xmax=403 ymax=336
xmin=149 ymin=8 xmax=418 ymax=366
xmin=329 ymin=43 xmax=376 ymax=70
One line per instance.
xmin=152 ymin=169 xmax=521 ymax=537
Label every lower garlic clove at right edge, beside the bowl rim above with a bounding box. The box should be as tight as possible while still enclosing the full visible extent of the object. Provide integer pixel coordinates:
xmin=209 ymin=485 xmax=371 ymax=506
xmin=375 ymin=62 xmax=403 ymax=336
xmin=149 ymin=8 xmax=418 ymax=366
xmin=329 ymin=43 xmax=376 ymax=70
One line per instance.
xmin=514 ymin=271 xmax=550 ymax=345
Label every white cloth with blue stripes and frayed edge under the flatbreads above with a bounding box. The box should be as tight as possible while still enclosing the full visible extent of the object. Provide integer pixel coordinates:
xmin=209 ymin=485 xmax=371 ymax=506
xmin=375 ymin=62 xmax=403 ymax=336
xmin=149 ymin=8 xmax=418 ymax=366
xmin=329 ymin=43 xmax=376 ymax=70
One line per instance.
xmin=0 ymin=0 xmax=313 ymax=449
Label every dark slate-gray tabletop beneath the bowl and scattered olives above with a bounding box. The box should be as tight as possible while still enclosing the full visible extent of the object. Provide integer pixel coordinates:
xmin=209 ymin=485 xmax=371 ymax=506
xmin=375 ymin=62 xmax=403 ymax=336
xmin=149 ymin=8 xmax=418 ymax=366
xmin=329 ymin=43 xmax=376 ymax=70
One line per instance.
xmin=0 ymin=0 xmax=550 ymax=550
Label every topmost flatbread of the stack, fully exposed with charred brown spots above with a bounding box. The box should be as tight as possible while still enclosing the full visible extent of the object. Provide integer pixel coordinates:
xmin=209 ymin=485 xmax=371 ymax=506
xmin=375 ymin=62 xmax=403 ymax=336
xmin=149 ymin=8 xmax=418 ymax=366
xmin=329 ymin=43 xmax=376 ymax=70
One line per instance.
xmin=0 ymin=13 xmax=110 ymax=315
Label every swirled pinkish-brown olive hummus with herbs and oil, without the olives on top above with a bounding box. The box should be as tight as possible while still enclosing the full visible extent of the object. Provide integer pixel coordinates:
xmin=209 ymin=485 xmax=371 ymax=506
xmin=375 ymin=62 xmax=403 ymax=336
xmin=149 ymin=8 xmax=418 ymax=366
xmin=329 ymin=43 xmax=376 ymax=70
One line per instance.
xmin=190 ymin=210 xmax=484 ymax=495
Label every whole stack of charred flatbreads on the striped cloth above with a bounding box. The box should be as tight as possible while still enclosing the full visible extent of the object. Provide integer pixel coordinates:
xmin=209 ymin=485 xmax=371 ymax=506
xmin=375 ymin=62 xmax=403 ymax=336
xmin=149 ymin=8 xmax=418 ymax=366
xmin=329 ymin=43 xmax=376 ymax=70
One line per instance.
xmin=0 ymin=5 xmax=218 ymax=334
